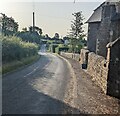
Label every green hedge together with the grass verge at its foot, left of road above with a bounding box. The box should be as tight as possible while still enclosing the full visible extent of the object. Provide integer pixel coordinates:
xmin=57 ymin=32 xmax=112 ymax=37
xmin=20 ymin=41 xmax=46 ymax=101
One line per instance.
xmin=0 ymin=35 xmax=39 ymax=74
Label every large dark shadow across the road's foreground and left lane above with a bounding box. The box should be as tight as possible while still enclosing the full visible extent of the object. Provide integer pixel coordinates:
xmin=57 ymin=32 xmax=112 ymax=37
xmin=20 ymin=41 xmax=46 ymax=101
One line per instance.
xmin=2 ymin=66 xmax=87 ymax=116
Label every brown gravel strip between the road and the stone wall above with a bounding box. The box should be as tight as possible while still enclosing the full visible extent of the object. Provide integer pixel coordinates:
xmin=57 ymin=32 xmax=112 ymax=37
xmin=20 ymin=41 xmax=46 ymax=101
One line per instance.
xmin=60 ymin=56 xmax=120 ymax=116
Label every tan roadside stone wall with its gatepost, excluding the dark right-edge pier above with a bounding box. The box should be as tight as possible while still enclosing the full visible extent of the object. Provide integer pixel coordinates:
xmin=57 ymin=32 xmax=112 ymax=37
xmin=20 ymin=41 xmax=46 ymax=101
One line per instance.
xmin=60 ymin=49 xmax=108 ymax=94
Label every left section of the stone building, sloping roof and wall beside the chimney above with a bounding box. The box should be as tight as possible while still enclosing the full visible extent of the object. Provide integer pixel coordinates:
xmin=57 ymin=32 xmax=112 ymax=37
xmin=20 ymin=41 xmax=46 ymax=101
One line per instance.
xmin=87 ymin=4 xmax=103 ymax=53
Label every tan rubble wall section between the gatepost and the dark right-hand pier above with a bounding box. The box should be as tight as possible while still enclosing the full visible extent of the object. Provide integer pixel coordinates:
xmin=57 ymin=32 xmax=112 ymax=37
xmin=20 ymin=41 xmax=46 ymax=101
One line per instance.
xmin=87 ymin=52 xmax=108 ymax=93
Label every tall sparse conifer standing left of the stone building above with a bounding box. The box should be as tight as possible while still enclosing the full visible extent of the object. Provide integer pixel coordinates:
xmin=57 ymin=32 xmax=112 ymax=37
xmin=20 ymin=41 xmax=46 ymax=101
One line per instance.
xmin=69 ymin=11 xmax=85 ymax=53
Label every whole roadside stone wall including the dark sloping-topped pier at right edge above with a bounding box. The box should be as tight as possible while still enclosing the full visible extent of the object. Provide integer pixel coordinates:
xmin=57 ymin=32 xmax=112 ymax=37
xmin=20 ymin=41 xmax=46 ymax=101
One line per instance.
xmin=61 ymin=46 xmax=120 ymax=99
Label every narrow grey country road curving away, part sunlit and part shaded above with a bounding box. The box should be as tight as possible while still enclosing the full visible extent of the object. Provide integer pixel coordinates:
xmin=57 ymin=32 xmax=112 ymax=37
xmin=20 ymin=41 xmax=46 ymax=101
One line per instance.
xmin=2 ymin=45 xmax=79 ymax=114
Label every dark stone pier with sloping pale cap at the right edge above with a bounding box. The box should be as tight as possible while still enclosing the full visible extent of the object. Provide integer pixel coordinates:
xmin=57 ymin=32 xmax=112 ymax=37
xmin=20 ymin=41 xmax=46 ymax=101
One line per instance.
xmin=107 ymin=38 xmax=120 ymax=99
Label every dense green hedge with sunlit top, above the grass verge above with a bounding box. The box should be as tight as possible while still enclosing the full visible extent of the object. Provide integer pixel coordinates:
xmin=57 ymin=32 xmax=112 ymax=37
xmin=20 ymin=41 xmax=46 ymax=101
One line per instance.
xmin=0 ymin=36 xmax=38 ymax=64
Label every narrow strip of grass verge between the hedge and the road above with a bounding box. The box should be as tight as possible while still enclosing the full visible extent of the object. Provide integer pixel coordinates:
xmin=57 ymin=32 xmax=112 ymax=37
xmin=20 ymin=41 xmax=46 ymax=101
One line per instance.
xmin=2 ymin=55 xmax=40 ymax=74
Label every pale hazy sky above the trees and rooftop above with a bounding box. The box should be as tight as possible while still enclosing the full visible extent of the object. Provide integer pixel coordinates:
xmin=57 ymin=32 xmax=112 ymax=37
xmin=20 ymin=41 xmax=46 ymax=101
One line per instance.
xmin=0 ymin=0 xmax=104 ymax=37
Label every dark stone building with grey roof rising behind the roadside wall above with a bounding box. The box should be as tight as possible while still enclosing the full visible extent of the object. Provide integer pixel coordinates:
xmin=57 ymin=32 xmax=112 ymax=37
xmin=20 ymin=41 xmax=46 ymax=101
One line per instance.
xmin=87 ymin=0 xmax=120 ymax=58
